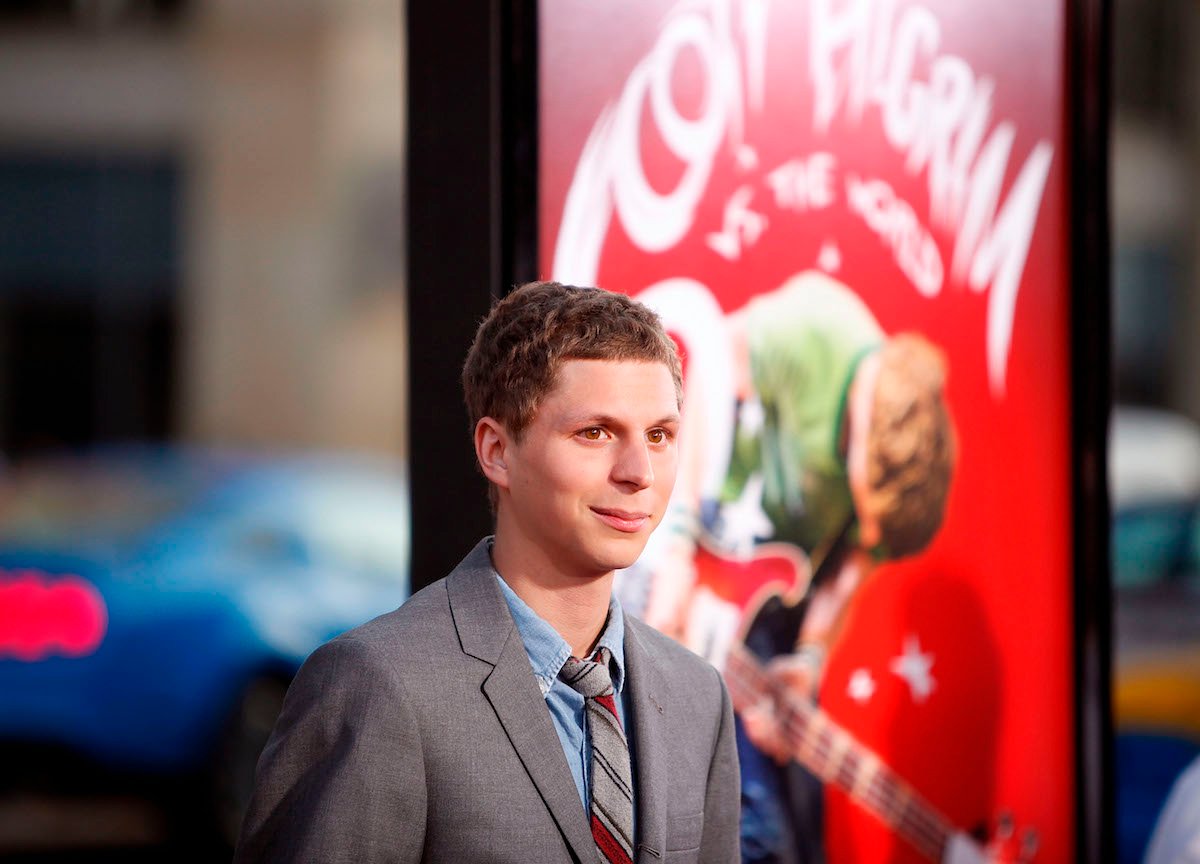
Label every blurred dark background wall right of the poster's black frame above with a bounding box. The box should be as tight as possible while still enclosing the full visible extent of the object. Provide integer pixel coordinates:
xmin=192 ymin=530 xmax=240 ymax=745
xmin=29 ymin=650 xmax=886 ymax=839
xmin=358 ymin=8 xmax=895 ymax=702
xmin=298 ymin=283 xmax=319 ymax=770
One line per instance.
xmin=1111 ymin=0 xmax=1200 ymax=420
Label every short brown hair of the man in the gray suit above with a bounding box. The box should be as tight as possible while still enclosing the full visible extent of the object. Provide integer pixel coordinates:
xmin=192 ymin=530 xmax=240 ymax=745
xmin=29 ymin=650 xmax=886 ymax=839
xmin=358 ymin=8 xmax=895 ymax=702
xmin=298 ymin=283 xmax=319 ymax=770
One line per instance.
xmin=462 ymin=282 xmax=683 ymax=440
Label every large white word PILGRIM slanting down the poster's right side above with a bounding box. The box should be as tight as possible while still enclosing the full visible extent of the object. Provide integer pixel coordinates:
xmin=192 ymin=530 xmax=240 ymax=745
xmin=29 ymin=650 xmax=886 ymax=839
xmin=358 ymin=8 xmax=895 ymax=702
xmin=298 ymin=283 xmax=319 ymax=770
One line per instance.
xmin=809 ymin=0 xmax=1054 ymax=394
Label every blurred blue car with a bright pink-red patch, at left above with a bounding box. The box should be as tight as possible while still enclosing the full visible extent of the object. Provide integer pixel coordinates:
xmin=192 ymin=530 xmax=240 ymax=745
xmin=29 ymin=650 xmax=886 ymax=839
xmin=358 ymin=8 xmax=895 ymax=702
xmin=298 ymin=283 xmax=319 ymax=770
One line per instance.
xmin=0 ymin=449 xmax=409 ymax=841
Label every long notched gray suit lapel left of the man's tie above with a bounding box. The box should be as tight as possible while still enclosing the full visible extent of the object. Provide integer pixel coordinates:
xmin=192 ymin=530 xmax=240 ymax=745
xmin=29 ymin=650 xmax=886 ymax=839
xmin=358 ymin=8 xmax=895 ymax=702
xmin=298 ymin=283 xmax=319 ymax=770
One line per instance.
xmin=446 ymin=540 xmax=595 ymax=862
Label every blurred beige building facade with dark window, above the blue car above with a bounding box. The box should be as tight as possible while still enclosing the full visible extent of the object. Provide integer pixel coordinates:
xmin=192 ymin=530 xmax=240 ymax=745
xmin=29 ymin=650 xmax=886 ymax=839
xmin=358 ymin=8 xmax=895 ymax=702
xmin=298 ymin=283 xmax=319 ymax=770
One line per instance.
xmin=0 ymin=0 xmax=406 ymax=456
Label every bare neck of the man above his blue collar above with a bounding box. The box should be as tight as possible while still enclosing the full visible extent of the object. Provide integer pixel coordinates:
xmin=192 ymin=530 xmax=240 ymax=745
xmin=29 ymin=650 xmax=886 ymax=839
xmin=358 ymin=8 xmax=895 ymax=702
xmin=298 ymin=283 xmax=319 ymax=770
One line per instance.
xmin=492 ymin=530 xmax=613 ymax=658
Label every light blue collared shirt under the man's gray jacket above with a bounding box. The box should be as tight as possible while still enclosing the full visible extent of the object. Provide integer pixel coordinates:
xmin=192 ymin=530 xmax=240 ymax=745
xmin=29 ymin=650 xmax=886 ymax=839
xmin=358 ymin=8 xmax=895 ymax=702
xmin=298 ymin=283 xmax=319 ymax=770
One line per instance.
xmin=496 ymin=574 xmax=637 ymax=827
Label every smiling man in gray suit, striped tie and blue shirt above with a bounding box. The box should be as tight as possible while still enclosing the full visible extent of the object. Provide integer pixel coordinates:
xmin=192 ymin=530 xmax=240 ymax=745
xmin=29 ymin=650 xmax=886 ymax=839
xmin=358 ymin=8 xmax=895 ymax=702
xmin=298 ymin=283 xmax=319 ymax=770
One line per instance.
xmin=235 ymin=283 xmax=739 ymax=864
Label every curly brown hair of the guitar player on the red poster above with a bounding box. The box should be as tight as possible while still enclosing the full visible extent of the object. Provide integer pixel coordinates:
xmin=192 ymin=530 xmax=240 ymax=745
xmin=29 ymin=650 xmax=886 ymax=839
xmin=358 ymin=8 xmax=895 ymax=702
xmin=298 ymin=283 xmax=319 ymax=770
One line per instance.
xmin=868 ymin=334 xmax=958 ymax=558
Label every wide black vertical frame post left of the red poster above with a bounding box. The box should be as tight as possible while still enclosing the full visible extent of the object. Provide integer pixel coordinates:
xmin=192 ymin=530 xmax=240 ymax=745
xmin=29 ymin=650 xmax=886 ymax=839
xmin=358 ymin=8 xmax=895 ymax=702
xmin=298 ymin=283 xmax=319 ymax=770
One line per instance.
xmin=406 ymin=0 xmax=538 ymax=589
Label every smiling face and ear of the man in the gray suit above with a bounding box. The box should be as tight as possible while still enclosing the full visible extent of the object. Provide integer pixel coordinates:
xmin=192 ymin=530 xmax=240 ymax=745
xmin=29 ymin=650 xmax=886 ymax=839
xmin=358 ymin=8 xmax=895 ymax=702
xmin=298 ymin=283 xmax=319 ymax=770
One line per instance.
xmin=500 ymin=360 xmax=679 ymax=577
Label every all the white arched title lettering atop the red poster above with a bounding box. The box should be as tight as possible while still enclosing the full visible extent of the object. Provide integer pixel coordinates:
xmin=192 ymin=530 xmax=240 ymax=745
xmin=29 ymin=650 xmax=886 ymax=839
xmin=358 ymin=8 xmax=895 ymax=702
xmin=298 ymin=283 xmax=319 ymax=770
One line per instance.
xmin=553 ymin=0 xmax=1054 ymax=395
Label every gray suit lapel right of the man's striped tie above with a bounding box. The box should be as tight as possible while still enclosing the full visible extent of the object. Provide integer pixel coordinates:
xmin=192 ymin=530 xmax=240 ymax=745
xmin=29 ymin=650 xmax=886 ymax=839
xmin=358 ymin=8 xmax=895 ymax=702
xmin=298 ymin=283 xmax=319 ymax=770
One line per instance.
xmin=625 ymin=617 xmax=668 ymax=864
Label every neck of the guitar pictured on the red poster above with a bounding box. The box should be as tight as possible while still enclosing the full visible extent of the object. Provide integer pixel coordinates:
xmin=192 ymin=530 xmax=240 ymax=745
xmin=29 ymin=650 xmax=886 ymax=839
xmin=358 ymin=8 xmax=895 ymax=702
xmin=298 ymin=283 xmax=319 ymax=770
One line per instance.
xmin=725 ymin=646 xmax=954 ymax=862
